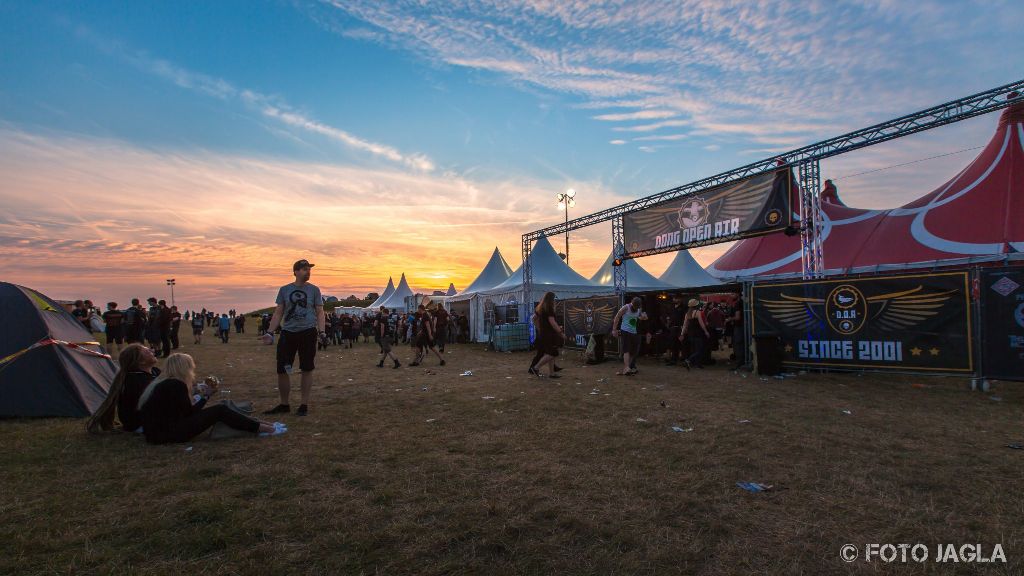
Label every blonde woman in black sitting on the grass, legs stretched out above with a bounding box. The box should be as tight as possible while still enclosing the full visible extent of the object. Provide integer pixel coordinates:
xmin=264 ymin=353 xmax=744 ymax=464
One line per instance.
xmin=138 ymin=354 xmax=288 ymax=444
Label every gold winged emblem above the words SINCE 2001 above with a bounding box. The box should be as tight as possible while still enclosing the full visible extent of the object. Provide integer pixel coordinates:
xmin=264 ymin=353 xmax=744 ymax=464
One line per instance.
xmin=761 ymin=284 xmax=956 ymax=335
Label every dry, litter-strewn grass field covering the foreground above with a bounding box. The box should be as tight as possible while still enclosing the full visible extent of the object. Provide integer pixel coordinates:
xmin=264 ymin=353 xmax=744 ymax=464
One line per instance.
xmin=0 ymin=335 xmax=1024 ymax=575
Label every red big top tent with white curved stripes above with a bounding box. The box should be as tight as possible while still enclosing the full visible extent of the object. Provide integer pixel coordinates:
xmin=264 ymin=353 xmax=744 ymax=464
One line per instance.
xmin=708 ymin=104 xmax=1024 ymax=280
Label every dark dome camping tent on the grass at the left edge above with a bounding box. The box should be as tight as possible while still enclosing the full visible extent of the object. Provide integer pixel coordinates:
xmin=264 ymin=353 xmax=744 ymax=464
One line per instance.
xmin=0 ymin=282 xmax=116 ymax=417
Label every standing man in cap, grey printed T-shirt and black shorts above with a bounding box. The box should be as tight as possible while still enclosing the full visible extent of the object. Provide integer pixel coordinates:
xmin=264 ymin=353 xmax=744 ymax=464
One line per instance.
xmin=263 ymin=259 xmax=327 ymax=416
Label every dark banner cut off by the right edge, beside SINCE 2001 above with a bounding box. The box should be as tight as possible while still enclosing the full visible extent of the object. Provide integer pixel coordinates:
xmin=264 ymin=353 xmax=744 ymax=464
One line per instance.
xmin=981 ymin=268 xmax=1024 ymax=380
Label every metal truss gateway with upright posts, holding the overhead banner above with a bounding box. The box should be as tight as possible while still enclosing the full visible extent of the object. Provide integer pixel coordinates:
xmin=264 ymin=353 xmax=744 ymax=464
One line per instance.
xmin=522 ymin=80 xmax=1024 ymax=297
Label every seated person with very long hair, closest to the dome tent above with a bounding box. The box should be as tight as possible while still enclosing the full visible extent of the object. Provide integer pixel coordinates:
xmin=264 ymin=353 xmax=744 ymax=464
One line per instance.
xmin=86 ymin=343 xmax=160 ymax=433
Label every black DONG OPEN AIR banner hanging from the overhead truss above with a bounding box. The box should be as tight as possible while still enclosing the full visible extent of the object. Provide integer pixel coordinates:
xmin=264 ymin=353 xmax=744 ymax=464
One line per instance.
xmin=623 ymin=168 xmax=796 ymax=258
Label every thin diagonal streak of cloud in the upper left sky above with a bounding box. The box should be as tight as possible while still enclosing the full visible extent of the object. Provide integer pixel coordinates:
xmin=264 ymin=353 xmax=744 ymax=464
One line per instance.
xmin=76 ymin=26 xmax=434 ymax=172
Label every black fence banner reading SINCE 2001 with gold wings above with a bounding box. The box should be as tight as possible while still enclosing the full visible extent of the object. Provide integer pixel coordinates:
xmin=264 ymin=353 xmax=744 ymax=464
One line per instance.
xmin=751 ymin=272 xmax=974 ymax=372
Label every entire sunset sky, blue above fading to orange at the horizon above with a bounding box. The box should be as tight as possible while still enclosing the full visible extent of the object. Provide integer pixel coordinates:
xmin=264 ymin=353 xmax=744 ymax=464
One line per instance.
xmin=0 ymin=0 xmax=1024 ymax=311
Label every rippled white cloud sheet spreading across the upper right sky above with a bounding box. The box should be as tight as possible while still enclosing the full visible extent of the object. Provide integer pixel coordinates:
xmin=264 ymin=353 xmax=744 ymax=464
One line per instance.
xmin=311 ymin=0 xmax=1024 ymax=149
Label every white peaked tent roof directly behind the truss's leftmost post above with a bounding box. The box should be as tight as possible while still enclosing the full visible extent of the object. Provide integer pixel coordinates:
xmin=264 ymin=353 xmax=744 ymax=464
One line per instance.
xmin=473 ymin=236 xmax=614 ymax=335
